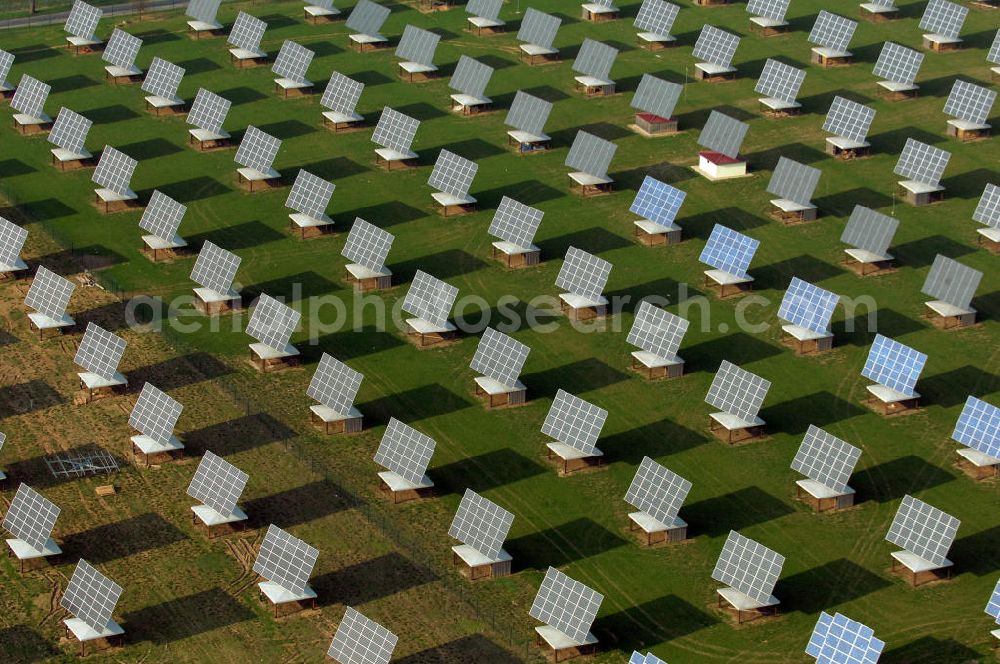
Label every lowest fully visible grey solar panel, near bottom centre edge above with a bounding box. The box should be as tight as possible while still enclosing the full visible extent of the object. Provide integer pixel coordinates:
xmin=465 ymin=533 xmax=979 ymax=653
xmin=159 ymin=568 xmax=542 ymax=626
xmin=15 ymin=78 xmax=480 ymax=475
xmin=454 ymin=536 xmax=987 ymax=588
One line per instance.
xmin=528 ymin=567 xmax=604 ymax=643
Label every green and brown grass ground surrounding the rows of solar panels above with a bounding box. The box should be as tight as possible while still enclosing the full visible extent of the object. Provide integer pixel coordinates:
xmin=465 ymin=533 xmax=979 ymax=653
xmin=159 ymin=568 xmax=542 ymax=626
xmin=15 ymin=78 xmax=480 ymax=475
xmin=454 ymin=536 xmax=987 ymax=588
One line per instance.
xmin=0 ymin=0 xmax=1000 ymax=664
